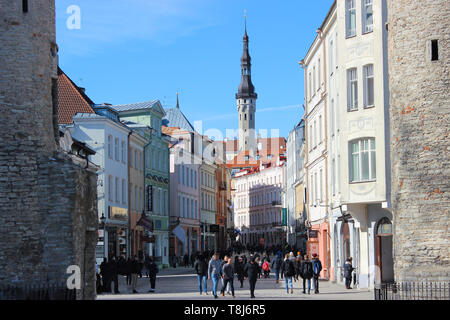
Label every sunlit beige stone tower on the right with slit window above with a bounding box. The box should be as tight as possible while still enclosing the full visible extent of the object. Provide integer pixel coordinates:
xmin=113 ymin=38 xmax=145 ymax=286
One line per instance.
xmin=388 ymin=0 xmax=450 ymax=281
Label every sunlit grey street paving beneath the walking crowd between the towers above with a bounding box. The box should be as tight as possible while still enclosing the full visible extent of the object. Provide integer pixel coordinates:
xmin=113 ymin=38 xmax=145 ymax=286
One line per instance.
xmin=97 ymin=268 xmax=373 ymax=300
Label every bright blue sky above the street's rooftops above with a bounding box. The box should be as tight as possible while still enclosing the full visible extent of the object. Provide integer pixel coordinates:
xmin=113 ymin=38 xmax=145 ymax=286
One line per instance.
xmin=56 ymin=0 xmax=333 ymax=137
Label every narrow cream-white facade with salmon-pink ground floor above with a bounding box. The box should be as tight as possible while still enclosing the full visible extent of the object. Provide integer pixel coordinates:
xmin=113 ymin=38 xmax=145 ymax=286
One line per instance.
xmin=301 ymin=18 xmax=330 ymax=279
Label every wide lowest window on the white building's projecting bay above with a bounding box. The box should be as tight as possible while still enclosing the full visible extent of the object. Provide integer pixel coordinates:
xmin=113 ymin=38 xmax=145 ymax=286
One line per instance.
xmin=350 ymin=138 xmax=376 ymax=182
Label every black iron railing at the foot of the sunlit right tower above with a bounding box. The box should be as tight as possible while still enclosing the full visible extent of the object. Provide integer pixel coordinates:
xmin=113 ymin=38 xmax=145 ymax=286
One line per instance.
xmin=374 ymin=282 xmax=450 ymax=300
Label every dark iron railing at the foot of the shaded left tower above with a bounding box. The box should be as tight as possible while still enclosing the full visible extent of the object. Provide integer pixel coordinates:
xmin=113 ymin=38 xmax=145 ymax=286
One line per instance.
xmin=0 ymin=282 xmax=77 ymax=300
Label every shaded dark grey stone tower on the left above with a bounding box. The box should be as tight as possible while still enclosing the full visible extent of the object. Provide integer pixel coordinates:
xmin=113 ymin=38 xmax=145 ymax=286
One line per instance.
xmin=0 ymin=0 xmax=98 ymax=299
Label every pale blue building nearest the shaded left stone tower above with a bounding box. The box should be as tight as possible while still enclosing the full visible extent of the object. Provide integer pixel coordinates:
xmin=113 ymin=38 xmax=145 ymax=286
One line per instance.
xmin=70 ymin=105 xmax=130 ymax=264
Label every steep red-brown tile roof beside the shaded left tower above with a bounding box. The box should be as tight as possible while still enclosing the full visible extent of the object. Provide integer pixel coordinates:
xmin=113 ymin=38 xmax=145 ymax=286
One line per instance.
xmin=58 ymin=68 xmax=95 ymax=124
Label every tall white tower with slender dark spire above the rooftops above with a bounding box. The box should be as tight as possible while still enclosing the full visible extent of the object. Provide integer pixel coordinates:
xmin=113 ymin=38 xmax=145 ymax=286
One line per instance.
xmin=236 ymin=16 xmax=258 ymax=153
